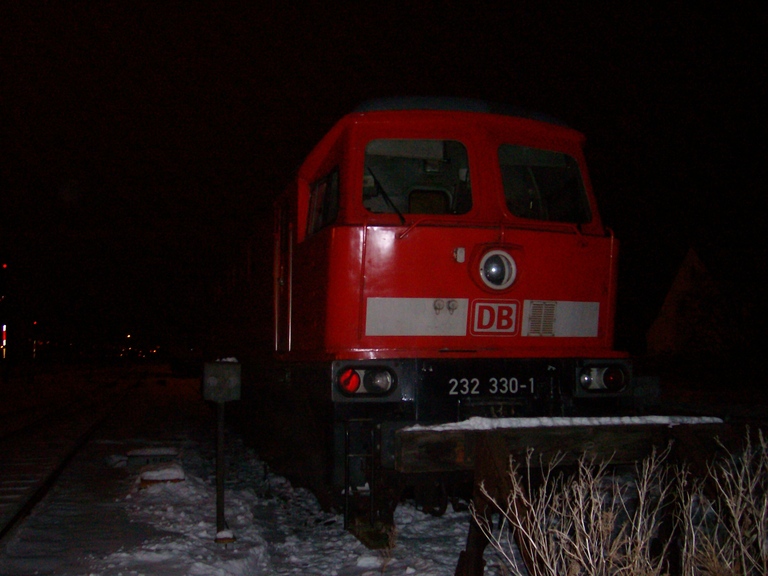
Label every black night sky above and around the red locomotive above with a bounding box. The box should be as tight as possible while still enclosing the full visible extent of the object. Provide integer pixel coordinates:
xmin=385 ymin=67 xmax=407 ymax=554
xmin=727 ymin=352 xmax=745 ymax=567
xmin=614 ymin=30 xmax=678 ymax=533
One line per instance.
xmin=0 ymin=1 xmax=768 ymax=358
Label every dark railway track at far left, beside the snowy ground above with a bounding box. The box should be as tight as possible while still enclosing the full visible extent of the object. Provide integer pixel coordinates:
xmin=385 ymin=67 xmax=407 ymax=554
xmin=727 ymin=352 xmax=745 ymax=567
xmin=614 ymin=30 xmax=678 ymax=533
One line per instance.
xmin=0 ymin=370 xmax=142 ymax=542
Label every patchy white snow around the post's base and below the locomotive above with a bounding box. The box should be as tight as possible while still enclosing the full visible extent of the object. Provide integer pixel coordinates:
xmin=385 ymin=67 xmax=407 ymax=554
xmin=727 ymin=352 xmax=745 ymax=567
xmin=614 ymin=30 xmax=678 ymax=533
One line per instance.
xmin=88 ymin=436 xmax=492 ymax=576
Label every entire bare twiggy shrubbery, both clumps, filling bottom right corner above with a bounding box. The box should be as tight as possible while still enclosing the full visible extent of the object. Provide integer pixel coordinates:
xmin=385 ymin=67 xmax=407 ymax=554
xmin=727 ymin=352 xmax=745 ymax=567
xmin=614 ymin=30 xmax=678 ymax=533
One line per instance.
xmin=471 ymin=432 xmax=768 ymax=576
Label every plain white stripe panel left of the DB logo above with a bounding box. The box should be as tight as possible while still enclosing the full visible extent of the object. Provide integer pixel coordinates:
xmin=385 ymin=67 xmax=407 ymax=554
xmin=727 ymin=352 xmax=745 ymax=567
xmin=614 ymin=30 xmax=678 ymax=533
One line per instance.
xmin=365 ymin=298 xmax=469 ymax=336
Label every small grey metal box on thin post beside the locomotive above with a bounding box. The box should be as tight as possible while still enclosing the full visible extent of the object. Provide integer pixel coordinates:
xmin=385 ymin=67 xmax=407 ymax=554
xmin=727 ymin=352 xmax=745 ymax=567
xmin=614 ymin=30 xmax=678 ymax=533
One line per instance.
xmin=203 ymin=358 xmax=240 ymax=544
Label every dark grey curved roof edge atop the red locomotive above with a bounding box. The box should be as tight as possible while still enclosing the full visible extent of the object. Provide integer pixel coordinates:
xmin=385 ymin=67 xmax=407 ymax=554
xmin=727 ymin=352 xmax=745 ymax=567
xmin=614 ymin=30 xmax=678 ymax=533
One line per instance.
xmin=355 ymin=96 xmax=567 ymax=127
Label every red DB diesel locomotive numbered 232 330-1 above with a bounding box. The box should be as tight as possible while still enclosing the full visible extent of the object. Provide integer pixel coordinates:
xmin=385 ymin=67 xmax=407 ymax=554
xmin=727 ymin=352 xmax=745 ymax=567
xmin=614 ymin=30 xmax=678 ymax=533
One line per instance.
xmin=274 ymin=98 xmax=636 ymax=528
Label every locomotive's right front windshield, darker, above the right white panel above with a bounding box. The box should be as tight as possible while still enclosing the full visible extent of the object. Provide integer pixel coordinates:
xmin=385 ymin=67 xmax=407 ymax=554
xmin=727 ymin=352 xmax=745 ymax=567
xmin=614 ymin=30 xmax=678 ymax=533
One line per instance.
xmin=499 ymin=144 xmax=592 ymax=224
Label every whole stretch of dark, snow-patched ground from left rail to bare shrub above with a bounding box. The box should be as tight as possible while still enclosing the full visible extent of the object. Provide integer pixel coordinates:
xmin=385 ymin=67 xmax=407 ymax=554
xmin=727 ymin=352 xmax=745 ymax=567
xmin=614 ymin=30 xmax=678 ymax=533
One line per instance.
xmin=0 ymin=382 xmax=510 ymax=576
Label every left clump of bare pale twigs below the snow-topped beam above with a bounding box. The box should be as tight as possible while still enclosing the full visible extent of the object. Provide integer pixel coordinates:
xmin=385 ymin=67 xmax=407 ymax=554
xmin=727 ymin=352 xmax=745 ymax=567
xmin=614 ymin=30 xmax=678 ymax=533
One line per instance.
xmin=472 ymin=450 xmax=673 ymax=576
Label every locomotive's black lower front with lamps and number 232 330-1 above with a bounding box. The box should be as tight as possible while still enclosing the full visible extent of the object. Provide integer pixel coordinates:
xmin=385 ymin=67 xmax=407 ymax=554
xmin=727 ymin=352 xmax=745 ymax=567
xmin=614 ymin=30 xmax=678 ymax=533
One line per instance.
xmin=331 ymin=358 xmax=644 ymax=547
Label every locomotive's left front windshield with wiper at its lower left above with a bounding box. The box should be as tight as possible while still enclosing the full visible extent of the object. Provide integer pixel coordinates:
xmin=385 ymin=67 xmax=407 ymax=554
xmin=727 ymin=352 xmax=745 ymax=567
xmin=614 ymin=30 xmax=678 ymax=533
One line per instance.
xmin=363 ymin=139 xmax=472 ymax=218
